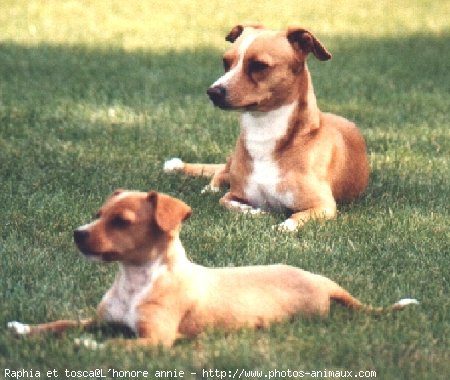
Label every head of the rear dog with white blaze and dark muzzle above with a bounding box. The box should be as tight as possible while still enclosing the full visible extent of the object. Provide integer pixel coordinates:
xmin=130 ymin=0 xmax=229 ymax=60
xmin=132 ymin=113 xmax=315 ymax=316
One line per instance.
xmin=207 ymin=25 xmax=331 ymax=112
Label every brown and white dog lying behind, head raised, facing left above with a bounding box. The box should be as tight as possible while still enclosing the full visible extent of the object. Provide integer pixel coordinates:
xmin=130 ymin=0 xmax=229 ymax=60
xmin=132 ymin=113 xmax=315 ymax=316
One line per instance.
xmin=164 ymin=25 xmax=369 ymax=230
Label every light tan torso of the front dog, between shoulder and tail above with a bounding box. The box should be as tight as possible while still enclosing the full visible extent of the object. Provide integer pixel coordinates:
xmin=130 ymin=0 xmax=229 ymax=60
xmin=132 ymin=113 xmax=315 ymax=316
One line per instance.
xmin=179 ymin=264 xmax=337 ymax=336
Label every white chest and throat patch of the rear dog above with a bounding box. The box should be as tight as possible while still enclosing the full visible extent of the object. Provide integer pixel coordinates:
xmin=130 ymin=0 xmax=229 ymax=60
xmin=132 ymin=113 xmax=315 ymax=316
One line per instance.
xmin=241 ymin=102 xmax=296 ymax=210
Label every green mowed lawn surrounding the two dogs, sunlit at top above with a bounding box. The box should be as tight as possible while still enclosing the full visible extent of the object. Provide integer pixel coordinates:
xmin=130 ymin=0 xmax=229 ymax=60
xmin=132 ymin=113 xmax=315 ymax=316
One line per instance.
xmin=0 ymin=0 xmax=450 ymax=379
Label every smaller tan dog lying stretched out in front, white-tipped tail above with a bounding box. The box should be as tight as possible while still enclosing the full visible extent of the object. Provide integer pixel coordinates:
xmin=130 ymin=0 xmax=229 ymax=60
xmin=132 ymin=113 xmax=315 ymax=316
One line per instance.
xmin=8 ymin=190 xmax=417 ymax=348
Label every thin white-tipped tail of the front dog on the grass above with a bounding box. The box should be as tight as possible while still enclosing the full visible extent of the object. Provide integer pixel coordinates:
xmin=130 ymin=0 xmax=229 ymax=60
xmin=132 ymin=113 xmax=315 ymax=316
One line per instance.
xmin=330 ymin=284 xmax=419 ymax=314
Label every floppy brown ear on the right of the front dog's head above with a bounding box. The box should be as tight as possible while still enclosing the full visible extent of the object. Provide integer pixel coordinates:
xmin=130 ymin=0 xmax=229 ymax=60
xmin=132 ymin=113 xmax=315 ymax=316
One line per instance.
xmin=147 ymin=191 xmax=192 ymax=232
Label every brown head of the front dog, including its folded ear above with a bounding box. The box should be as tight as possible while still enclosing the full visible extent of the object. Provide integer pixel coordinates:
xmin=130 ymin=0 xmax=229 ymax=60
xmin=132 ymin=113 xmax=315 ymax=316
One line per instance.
xmin=74 ymin=190 xmax=191 ymax=263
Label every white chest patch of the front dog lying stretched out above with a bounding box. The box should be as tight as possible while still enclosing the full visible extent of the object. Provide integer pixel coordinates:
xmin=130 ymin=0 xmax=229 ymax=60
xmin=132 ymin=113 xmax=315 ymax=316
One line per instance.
xmin=102 ymin=260 xmax=167 ymax=332
